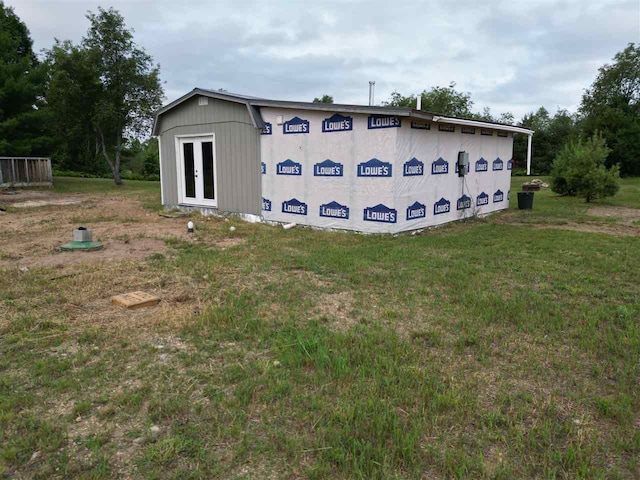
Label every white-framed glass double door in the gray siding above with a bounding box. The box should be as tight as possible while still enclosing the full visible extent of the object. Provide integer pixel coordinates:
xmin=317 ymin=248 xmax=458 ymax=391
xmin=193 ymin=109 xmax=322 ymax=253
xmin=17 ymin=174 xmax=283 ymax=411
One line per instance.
xmin=176 ymin=133 xmax=218 ymax=207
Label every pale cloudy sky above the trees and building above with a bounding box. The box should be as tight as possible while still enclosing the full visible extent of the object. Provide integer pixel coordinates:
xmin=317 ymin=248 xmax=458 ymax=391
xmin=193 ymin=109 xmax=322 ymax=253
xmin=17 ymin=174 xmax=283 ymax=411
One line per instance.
xmin=10 ymin=0 xmax=640 ymax=119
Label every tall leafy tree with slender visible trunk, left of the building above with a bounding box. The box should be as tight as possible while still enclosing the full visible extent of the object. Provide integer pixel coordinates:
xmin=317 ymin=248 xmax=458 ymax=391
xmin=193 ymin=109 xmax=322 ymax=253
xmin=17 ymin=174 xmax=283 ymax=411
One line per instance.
xmin=47 ymin=7 xmax=163 ymax=185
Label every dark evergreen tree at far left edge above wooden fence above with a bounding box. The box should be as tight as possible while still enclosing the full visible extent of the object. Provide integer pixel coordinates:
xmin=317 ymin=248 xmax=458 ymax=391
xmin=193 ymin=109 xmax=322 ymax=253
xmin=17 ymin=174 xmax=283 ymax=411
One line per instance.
xmin=0 ymin=1 xmax=51 ymax=155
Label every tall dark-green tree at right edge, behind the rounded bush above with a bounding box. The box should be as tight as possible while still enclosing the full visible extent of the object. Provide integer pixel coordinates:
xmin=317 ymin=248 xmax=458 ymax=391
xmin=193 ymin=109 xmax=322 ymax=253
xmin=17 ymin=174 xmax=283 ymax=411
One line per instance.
xmin=579 ymin=43 xmax=640 ymax=175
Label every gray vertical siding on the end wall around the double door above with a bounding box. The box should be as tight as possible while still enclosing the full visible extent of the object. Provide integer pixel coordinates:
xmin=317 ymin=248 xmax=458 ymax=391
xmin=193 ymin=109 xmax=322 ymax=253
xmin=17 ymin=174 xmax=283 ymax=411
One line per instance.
xmin=159 ymin=96 xmax=262 ymax=215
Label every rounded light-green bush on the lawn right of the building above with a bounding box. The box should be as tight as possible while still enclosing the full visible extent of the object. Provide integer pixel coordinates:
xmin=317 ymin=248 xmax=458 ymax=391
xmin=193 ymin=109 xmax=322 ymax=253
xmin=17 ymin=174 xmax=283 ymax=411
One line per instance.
xmin=551 ymin=132 xmax=620 ymax=202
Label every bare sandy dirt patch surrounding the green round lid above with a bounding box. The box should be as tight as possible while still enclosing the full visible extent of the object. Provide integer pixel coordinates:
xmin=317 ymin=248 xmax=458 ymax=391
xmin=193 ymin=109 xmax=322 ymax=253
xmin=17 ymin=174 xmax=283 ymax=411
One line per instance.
xmin=0 ymin=190 xmax=191 ymax=268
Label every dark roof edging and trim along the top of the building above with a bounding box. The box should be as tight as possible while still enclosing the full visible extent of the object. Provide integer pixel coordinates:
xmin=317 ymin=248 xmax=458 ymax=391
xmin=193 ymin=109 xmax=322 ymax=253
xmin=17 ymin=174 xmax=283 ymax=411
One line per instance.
xmin=153 ymin=88 xmax=533 ymax=135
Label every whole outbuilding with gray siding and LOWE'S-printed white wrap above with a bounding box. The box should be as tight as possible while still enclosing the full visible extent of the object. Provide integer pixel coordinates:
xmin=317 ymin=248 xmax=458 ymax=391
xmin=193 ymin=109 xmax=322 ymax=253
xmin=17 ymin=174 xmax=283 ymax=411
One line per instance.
xmin=153 ymin=89 xmax=533 ymax=233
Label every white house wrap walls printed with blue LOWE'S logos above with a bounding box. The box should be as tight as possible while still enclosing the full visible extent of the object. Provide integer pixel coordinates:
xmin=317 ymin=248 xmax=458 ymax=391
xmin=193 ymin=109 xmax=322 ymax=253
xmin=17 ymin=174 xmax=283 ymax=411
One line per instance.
xmin=261 ymin=108 xmax=513 ymax=233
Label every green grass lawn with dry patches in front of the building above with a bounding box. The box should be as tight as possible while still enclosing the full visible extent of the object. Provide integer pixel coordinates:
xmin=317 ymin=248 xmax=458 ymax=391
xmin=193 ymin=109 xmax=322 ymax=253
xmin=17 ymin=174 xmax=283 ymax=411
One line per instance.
xmin=0 ymin=177 xmax=640 ymax=479
